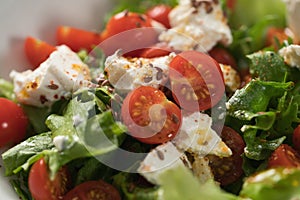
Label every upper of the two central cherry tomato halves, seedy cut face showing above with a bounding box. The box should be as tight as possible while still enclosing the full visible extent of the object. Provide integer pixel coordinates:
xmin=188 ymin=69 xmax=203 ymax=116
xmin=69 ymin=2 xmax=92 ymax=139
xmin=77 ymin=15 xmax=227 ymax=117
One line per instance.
xmin=169 ymin=51 xmax=225 ymax=111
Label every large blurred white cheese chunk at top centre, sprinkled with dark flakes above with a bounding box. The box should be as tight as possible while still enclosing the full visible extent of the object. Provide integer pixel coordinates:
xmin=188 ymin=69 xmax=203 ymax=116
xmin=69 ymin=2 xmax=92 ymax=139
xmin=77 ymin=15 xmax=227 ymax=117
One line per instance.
xmin=159 ymin=0 xmax=232 ymax=52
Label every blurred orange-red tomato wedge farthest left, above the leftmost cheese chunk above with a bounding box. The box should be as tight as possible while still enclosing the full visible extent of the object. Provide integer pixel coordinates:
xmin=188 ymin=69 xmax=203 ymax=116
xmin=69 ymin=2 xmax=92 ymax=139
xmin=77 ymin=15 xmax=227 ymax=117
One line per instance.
xmin=24 ymin=37 xmax=56 ymax=69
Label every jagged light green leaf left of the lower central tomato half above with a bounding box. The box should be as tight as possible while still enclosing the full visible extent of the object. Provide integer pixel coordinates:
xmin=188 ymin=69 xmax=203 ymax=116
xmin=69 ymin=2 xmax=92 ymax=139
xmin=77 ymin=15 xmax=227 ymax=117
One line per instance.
xmin=44 ymin=91 xmax=125 ymax=175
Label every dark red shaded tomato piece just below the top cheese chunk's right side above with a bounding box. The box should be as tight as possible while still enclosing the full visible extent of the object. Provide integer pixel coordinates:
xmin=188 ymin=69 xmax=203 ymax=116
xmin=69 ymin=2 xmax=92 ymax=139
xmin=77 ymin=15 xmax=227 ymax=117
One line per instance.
xmin=208 ymin=47 xmax=237 ymax=69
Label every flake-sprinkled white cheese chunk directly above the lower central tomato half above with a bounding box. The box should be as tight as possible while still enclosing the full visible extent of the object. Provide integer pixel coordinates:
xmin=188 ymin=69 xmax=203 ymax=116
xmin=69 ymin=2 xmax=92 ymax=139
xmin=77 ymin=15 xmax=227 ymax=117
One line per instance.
xmin=105 ymin=51 xmax=175 ymax=92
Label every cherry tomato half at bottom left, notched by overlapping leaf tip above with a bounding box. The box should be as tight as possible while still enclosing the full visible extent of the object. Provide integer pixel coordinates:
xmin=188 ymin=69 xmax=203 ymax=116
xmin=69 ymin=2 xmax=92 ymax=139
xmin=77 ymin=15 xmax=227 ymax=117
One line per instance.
xmin=28 ymin=158 xmax=70 ymax=200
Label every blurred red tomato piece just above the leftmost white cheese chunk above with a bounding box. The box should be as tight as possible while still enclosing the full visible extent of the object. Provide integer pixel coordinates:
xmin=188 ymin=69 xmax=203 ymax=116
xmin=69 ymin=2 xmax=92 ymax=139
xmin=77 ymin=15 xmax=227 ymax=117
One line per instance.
xmin=56 ymin=26 xmax=102 ymax=52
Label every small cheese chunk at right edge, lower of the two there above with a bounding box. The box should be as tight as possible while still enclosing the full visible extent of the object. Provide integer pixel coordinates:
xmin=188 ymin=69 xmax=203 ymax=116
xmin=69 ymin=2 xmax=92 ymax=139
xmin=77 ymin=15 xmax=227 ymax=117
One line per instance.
xmin=278 ymin=44 xmax=300 ymax=69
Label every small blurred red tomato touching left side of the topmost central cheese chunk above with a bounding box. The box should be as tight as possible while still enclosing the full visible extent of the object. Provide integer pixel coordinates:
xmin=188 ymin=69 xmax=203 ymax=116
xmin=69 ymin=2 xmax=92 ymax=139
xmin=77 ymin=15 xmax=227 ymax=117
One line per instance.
xmin=146 ymin=4 xmax=172 ymax=29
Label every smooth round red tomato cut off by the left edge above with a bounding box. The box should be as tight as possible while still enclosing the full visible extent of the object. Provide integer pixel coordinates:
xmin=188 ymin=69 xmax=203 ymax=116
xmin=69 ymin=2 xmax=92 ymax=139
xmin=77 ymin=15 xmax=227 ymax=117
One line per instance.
xmin=0 ymin=98 xmax=29 ymax=147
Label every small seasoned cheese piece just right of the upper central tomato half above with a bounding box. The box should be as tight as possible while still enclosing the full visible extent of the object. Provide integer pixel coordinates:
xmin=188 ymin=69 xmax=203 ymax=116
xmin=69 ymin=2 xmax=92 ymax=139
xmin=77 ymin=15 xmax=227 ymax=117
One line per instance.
xmin=219 ymin=63 xmax=241 ymax=92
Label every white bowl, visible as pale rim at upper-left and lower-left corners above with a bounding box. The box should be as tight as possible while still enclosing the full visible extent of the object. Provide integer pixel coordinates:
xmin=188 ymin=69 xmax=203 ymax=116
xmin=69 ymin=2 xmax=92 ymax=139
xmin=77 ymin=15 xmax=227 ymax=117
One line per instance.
xmin=0 ymin=0 xmax=115 ymax=200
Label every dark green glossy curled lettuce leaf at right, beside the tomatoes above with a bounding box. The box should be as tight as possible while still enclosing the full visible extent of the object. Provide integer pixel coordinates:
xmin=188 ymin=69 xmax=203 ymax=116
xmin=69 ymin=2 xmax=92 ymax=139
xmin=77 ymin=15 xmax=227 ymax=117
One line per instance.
xmin=227 ymin=80 xmax=298 ymax=160
